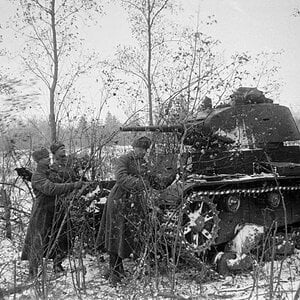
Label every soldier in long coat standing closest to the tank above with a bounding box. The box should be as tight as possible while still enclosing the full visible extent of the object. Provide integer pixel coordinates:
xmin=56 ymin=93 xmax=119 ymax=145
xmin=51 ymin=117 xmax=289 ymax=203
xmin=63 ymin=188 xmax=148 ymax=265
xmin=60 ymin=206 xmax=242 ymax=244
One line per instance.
xmin=97 ymin=137 xmax=175 ymax=285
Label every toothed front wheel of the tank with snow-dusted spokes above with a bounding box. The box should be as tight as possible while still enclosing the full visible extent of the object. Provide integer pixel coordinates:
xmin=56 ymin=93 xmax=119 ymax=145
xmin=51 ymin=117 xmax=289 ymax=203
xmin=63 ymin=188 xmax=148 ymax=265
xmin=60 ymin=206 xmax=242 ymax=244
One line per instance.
xmin=181 ymin=192 xmax=220 ymax=254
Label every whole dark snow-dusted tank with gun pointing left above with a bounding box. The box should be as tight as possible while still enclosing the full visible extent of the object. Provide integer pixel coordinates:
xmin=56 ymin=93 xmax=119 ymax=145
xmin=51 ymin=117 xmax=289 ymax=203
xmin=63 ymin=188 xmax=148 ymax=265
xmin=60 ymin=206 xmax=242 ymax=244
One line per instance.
xmin=121 ymin=88 xmax=300 ymax=253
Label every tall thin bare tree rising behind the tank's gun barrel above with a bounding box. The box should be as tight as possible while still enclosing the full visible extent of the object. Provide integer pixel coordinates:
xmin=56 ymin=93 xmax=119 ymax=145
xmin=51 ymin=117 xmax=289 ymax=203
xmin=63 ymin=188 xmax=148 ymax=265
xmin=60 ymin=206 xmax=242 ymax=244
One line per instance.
xmin=112 ymin=0 xmax=178 ymax=125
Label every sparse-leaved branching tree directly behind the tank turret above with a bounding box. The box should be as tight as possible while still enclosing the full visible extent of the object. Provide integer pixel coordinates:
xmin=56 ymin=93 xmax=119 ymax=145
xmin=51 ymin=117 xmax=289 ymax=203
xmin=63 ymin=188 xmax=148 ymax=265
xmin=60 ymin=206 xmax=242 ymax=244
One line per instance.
xmin=148 ymin=22 xmax=281 ymax=123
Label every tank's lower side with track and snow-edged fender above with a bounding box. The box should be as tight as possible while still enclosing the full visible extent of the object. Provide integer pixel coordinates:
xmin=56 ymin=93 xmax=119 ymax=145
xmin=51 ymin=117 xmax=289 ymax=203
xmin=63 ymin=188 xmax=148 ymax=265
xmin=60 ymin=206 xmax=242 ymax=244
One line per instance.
xmin=160 ymin=173 xmax=300 ymax=252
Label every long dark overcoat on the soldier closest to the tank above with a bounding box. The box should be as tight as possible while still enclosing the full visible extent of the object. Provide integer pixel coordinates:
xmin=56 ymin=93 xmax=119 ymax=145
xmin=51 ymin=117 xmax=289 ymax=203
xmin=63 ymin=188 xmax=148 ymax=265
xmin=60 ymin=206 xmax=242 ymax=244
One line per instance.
xmin=97 ymin=151 xmax=176 ymax=259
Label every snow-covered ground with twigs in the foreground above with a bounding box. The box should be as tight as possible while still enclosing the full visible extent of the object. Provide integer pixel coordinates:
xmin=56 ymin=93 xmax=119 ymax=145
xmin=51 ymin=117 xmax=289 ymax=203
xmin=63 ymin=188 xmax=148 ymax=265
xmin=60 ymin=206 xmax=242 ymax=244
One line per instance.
xmin=0 ymin=239 xmax=300 ymax=300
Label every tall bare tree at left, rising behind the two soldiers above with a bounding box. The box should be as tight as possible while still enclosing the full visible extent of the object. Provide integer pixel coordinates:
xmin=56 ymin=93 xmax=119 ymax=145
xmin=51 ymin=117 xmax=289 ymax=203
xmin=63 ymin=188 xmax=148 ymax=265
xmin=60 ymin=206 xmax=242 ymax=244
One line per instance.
xmin=12 ymin=0 xmax=101 ymax=141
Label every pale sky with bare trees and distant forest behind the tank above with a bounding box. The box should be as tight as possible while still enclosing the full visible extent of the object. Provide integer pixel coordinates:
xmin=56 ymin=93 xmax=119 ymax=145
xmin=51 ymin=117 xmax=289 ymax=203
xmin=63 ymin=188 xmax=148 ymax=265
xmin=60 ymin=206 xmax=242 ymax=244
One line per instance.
xmin=0 ymin=0 xmax=299 ymax=155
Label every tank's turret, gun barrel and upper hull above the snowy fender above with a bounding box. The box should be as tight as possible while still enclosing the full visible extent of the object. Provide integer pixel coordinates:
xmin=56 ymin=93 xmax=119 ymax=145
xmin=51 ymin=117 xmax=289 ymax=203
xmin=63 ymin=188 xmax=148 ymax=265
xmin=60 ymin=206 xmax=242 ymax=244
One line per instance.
xmin=121 ymin=88 xmax=300 ymax=175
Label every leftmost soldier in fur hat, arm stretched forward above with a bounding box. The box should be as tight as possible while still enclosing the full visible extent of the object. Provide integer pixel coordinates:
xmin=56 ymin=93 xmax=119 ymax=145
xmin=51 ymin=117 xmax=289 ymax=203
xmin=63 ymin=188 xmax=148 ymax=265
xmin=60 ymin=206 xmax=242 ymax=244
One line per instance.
xmin=21 ymin=148 xmax=84 ymax=277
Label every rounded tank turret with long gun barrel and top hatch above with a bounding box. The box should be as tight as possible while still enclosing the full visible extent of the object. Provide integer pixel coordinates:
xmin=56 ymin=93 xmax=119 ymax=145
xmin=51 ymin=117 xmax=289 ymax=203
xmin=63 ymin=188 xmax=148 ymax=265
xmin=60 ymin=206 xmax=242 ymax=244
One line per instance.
xmin=121 ymin=88 xmax=300 ymax=149
